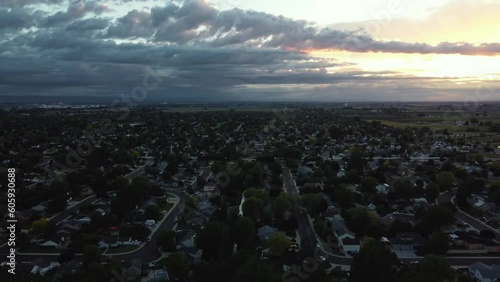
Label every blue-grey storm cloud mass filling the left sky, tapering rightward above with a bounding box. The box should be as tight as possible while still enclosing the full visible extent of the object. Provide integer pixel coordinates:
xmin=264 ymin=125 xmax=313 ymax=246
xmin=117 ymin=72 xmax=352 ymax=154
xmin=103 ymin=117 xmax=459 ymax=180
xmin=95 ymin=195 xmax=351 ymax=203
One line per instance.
xmin=0 ymin=0 xmax=500 ymax=99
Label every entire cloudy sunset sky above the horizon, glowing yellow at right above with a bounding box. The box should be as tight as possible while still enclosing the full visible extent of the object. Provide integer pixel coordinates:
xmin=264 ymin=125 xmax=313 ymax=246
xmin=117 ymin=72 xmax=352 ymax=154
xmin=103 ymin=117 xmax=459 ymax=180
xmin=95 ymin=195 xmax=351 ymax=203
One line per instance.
xmin=0 ymin=0 xmax=500 ymax=103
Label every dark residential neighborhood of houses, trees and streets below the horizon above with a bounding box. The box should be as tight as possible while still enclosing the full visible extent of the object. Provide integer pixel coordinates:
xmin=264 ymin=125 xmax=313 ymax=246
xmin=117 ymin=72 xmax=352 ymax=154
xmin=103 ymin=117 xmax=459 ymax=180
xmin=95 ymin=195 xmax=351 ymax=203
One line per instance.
xmin=0 ymin=105 xmax=500 ymax=281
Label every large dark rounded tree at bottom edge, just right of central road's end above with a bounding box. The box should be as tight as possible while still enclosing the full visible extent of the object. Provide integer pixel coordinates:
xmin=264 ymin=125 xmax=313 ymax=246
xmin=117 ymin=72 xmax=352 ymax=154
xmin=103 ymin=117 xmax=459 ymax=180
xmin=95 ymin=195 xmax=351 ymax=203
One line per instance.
xmin=350 ymin=238 xmax=396 ymax=282
